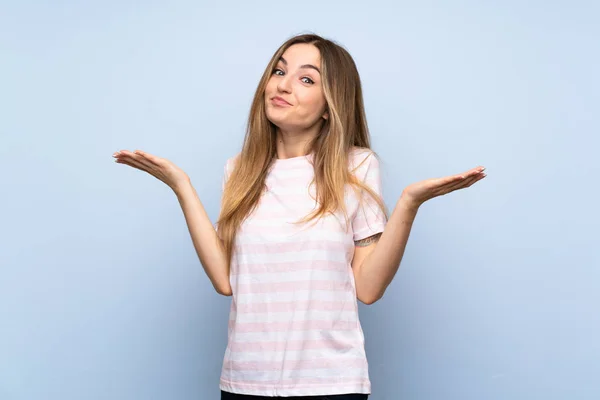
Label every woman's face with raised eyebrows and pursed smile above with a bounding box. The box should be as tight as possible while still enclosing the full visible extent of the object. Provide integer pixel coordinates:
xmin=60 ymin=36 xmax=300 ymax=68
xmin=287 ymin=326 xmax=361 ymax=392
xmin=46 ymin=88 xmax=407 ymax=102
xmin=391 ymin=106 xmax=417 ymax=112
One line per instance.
xmin=265 ymin=43 xmax=327 ymax=131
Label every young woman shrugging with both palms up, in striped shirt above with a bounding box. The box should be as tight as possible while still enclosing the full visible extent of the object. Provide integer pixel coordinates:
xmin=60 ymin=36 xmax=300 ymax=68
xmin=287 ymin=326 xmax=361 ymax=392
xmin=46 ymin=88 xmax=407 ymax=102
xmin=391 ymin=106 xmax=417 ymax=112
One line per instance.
xmin=114 ymin=35 xmax=485 ymax=400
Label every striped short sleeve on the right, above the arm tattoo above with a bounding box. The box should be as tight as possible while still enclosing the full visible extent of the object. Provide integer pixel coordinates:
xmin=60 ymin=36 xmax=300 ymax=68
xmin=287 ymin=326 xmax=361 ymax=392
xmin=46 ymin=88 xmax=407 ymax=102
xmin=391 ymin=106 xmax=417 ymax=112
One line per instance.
xmin=352 ymin=151 xmax=387 ymax=241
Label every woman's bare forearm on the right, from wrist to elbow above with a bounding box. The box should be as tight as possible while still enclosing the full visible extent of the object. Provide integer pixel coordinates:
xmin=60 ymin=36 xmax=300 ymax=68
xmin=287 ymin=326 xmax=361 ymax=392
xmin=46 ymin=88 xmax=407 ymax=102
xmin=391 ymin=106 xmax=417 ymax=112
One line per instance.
xmin=358 ymin=196 xmax=419 ymax=301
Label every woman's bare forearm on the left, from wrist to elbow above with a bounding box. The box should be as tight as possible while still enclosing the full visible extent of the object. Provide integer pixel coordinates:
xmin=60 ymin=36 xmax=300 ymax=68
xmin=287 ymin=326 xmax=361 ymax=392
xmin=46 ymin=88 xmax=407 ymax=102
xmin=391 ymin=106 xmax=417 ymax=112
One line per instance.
xmin=174 ymin=182 xmax=231 ymax=296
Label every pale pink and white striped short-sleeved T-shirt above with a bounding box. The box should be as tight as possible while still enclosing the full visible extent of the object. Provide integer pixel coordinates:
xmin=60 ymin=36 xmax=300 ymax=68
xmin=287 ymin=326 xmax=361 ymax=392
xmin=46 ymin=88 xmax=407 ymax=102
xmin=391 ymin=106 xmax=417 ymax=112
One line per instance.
xmin=219 ymin=148 xmax=386 ymax=396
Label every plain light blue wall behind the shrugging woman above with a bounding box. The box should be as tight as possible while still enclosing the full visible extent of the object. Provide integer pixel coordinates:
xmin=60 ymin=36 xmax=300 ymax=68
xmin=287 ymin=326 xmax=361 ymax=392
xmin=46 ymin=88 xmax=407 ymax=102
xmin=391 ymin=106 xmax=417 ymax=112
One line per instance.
xmin=0 ymin=0 xmax=600 ymax=400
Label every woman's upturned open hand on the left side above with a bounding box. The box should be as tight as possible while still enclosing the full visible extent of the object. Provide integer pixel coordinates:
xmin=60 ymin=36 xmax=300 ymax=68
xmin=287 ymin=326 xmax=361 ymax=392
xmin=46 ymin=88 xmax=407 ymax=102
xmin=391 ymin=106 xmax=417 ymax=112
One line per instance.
xmin=113 ymin=150 xmax=190 ymax=191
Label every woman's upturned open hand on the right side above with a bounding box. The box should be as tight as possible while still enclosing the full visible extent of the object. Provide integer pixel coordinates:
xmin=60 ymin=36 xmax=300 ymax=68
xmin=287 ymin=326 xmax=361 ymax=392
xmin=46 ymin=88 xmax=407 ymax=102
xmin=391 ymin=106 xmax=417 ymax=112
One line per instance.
xmin=402 ymin=166 xmax=486 ymax=208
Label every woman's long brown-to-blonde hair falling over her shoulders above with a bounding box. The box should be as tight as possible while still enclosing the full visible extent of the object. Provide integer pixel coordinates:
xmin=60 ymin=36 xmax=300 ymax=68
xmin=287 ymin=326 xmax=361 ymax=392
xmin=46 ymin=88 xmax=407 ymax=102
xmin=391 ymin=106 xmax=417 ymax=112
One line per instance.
xmin=217 ymin=34 xmax=389 ymax=268
